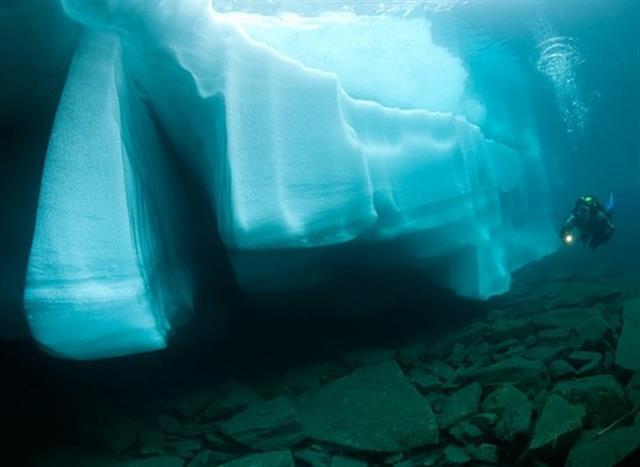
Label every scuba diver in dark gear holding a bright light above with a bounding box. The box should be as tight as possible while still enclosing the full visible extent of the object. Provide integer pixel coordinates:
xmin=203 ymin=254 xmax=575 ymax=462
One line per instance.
xmin=560 ymin=193 xmax=616 ymax=250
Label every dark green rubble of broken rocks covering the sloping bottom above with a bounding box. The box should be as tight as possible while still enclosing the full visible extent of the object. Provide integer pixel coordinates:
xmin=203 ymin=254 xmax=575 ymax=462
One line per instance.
xmin=40 ymin=272 xmax=640 ymax=467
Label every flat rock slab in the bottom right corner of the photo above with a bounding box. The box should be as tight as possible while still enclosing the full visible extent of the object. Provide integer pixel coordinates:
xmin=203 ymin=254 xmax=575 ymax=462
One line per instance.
xmin=565 ymin=425 xmax=640 ymax=467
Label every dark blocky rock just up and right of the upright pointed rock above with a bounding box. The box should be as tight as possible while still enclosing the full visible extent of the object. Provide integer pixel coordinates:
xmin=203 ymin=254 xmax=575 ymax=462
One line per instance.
xmin=552 ymin=375 xmax=627 ymax=428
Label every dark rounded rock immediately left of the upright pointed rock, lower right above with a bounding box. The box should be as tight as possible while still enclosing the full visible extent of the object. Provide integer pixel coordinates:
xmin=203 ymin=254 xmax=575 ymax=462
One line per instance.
xmin=482 ymin=384 xmax=531 ymax=442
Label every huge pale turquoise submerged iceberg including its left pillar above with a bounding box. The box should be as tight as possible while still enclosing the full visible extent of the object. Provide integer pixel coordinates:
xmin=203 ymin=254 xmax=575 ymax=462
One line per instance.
xmin=25 ymin=1 xmax=556 ymax=359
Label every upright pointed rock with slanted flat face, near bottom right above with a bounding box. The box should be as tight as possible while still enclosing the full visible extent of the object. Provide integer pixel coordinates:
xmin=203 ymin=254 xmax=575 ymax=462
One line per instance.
xmin=528 ymin=394 xmax=586 ymax=454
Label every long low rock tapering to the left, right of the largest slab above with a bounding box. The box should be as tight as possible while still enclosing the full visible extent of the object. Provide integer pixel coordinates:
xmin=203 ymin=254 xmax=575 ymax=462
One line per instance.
xmin=460 ymin=357 xmax=549 ymax=392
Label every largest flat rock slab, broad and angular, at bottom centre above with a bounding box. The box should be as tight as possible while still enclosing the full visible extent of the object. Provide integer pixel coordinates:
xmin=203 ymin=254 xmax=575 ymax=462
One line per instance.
xmin=296 ymin=362 xmax=439 ymax=452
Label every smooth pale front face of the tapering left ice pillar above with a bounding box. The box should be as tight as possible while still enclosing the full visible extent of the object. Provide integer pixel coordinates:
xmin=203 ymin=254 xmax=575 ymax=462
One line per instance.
xmin=25 ymin=37 xmax=165 ymax=358
